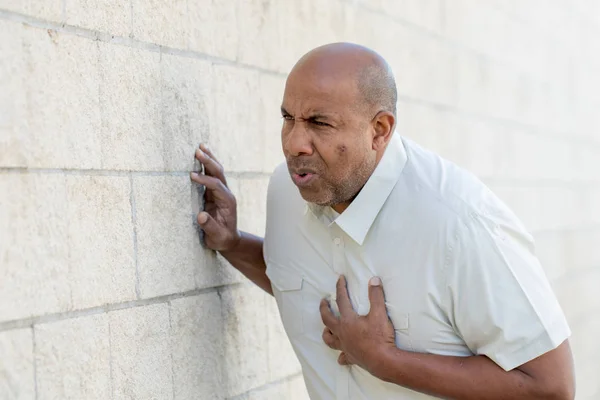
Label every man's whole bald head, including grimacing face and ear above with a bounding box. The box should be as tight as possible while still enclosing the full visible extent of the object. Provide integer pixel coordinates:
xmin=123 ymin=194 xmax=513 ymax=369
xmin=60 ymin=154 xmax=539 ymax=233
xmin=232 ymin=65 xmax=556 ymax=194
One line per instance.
xmin=281 ymin=43 xmax=397 ymax=212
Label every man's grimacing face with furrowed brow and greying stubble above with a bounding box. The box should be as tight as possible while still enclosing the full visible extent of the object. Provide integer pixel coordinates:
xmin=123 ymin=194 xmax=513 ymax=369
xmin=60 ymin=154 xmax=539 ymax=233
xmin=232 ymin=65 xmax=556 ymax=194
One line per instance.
xmin=281 ymin=72 xmax=376 ymax=206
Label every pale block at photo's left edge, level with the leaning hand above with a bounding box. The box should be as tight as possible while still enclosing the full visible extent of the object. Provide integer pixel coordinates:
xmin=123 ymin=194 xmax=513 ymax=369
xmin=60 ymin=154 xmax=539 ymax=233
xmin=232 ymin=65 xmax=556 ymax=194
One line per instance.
xmin=0 ymin=173 xmax=71 ymax=321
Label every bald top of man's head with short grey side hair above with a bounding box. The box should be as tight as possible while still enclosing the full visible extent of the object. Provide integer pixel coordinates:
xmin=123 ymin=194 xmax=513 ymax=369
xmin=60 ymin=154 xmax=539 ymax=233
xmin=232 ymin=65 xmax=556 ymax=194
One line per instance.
xmin=290 ymin=43 xmax=398 ymax=115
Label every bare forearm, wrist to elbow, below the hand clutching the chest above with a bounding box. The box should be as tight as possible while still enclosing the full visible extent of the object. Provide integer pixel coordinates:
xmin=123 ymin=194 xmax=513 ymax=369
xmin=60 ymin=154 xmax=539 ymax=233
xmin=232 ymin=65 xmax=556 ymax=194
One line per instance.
xmin=373 ymin=349 xmax=562 ymax=400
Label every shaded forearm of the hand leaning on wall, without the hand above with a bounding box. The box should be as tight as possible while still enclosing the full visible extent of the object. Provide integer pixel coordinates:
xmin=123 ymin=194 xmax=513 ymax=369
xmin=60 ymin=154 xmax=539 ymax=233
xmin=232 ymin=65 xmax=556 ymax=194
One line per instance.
xmin=220 ymin=232 xmax=273 ymax=295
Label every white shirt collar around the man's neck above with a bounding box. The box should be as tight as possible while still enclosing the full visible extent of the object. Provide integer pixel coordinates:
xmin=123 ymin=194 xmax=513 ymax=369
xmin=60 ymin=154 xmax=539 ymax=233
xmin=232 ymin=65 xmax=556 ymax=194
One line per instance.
xmin=307 ymin=133 xmax=408 ymax=245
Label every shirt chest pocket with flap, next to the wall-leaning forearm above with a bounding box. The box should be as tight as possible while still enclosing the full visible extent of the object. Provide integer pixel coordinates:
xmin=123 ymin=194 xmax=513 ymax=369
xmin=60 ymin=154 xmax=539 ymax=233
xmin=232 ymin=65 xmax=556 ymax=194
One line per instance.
xmin=267 ymin=263 xmax=306 ymax=337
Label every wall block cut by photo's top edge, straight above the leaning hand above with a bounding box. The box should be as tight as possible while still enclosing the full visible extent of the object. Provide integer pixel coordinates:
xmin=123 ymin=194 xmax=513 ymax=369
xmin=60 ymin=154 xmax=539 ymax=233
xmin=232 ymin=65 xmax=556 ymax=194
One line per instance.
xmin=187 ymin=0 xmax=241 ymax=60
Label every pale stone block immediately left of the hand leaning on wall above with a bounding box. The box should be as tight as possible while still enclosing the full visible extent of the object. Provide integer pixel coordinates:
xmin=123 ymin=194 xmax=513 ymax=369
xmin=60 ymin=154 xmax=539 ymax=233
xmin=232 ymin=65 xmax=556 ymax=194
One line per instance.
xmin=134 ymin=175 xmax=221 ymax=298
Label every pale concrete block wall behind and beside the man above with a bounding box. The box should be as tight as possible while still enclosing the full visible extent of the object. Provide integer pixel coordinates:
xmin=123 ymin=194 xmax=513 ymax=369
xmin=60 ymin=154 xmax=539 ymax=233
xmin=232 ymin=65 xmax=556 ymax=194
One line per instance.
xmin=0 ymin=0 xmax=600 ymax=400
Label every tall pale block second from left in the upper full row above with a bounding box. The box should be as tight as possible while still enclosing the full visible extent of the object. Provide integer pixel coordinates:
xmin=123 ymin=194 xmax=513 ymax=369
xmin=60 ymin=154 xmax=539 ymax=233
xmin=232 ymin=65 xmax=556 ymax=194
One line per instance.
xmin=17 ymin=27 xmax=101 ymax=169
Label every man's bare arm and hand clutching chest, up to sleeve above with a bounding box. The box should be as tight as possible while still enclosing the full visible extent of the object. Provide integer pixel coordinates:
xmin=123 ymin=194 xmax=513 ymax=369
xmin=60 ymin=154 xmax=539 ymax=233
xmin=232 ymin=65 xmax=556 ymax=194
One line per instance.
xmin=320 ymin=277 xmax=575 ymax=400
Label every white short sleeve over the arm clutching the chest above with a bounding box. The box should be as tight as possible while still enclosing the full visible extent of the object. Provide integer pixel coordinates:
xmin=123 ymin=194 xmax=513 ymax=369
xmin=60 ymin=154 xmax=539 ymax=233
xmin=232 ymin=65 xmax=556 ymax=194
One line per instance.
xmin=446 ymin=214 xmax=571 ymax=371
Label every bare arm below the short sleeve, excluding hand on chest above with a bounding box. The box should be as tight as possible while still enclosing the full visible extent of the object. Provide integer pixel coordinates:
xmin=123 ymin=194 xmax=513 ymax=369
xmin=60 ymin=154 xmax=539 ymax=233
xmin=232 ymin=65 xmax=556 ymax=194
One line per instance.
xmin=373 ymin=341 xmax=575 ymax=400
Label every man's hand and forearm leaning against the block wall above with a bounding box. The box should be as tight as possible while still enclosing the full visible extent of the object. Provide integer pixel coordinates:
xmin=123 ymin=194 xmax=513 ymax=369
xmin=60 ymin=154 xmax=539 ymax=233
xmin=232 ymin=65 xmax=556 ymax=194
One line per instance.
xmin=191 ymin=145 xmax=273 ymax=295
